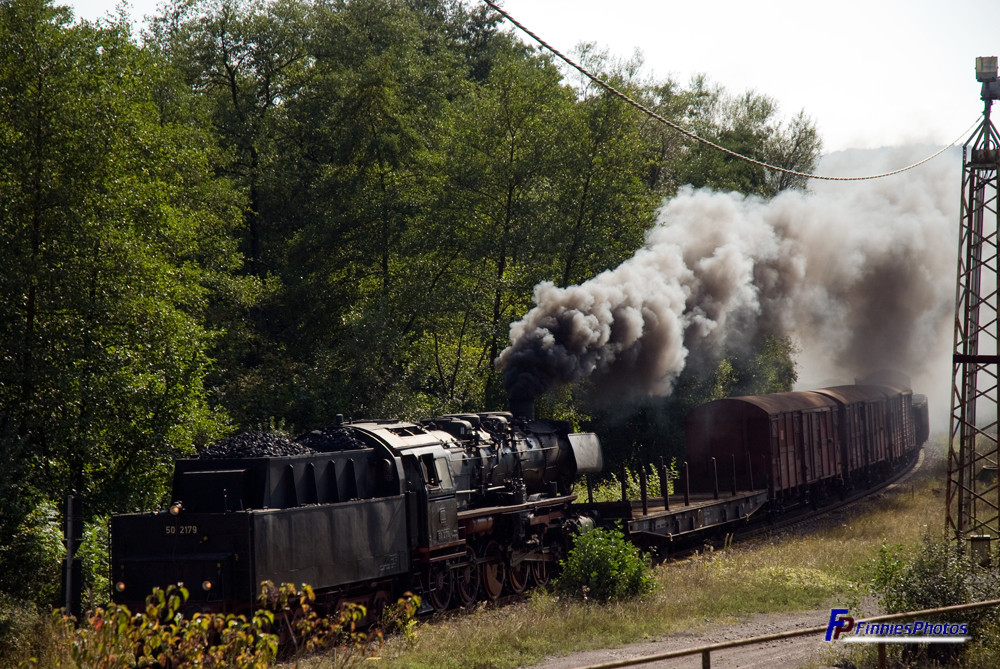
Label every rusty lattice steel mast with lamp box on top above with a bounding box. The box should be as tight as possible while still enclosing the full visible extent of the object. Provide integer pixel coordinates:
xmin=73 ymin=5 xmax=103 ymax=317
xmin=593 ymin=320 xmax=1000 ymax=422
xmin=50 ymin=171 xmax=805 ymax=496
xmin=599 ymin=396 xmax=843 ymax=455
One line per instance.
xmin=946 ymin=56 xmax=1000 ymax=542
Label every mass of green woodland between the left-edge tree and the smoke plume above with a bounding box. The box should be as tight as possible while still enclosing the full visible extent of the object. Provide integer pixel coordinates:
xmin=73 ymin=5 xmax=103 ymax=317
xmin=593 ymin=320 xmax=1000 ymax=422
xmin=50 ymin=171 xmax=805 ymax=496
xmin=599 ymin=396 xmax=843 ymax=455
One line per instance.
xmin=156 ymin=0 xmax=818 ymax=429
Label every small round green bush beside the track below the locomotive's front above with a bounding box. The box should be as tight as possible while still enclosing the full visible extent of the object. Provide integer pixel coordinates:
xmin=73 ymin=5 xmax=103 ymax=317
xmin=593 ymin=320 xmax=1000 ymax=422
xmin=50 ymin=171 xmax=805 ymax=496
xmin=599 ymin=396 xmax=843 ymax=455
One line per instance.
xmin=555 ymin=528 xmax=654 ymax=602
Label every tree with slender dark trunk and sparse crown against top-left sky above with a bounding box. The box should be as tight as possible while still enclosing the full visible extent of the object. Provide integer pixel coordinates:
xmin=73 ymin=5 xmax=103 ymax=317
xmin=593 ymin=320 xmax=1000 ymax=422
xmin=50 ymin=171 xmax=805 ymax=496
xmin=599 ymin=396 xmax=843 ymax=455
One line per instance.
xmin=147 ymin=0 xmax=312 ymax=276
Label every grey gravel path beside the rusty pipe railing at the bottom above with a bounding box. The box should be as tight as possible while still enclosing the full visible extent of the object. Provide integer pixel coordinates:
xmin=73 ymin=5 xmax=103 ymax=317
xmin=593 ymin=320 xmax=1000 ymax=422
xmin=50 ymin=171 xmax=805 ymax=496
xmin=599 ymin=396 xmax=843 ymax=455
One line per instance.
xmin=530 ymin=609 xmax=836 ymax=669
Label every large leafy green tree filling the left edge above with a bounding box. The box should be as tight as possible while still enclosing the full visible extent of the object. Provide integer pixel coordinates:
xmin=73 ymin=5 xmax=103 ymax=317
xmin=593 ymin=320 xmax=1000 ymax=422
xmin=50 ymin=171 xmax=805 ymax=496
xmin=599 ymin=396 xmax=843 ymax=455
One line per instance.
xmin=0 ymin=0 xmax=241 ymax=512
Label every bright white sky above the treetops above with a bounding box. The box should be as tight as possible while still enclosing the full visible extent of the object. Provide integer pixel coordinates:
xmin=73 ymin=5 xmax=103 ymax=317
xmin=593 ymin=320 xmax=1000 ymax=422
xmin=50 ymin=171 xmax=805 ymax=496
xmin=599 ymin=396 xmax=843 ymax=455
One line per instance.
xmin=64 ymin=0 xmax=1000 ymax=152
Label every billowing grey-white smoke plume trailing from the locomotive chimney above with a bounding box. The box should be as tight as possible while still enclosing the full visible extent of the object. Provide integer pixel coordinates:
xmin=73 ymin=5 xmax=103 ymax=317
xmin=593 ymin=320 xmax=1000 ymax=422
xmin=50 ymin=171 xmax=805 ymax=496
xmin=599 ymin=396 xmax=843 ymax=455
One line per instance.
xmin=498 ymin=146 xmax=961 ymax=428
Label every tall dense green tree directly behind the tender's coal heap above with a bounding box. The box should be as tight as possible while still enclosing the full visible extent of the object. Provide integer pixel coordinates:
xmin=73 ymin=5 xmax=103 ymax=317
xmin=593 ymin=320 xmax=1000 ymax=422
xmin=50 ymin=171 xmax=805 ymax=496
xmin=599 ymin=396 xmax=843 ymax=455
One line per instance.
xmin=206 ymin=0 xmax=464 ymax=427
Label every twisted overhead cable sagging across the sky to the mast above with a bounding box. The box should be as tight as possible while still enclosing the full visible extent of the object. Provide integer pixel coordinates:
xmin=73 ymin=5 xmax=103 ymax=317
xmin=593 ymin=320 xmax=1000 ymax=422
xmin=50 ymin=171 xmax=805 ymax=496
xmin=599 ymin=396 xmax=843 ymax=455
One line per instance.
xmin=483 ymin=0 xmax=980 ymax=181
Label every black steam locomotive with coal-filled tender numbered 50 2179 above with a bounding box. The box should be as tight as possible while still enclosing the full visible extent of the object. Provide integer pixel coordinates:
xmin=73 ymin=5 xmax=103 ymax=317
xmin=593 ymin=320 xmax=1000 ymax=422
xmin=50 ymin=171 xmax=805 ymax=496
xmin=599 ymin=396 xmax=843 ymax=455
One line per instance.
xmin=111 ymin=412 xmax=602 ymax=611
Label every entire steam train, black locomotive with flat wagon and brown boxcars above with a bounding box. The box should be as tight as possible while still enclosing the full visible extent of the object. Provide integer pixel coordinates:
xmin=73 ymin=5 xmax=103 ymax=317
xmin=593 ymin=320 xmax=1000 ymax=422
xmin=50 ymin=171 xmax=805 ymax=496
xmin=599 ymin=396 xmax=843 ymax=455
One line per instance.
xmin=111 ymin=377 xmax=928 ymax=611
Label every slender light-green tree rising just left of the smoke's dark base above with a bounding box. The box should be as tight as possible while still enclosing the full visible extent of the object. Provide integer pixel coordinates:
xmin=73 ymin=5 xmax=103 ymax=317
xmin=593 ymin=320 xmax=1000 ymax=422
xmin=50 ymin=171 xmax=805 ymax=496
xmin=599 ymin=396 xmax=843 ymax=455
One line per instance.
xmin=447 ymin=43 xmax=574 ymax=408
